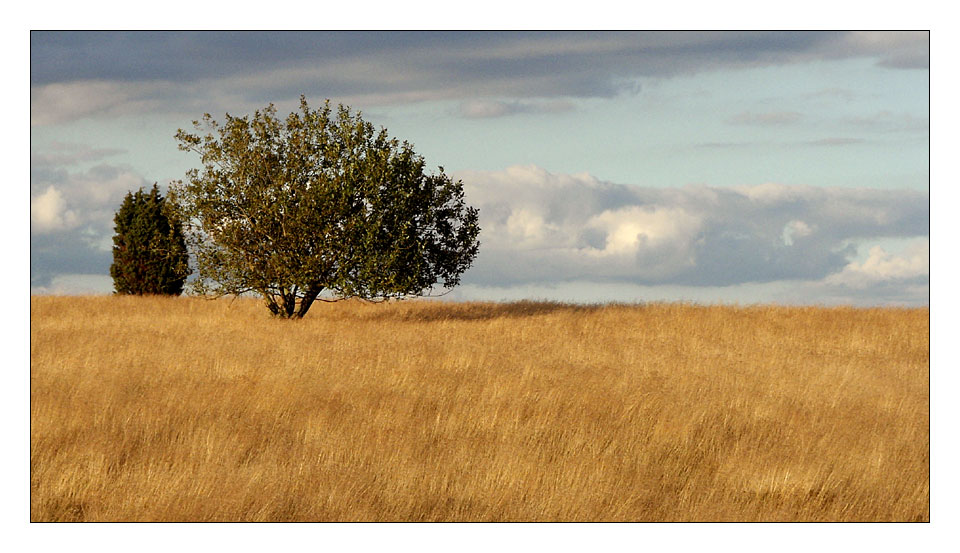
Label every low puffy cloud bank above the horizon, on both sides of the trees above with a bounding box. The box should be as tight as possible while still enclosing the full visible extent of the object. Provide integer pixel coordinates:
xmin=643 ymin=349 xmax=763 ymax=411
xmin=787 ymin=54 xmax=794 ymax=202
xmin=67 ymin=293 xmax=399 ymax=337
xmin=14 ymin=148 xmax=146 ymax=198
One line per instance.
xmin=31 ymin=160 xmax=929 ymax=305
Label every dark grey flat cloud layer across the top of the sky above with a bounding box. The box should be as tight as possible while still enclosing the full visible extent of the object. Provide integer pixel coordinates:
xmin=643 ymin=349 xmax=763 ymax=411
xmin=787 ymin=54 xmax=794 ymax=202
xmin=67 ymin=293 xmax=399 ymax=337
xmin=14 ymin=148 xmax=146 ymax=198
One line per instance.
xmin=30 ymin=32 xmax=929 ymax=124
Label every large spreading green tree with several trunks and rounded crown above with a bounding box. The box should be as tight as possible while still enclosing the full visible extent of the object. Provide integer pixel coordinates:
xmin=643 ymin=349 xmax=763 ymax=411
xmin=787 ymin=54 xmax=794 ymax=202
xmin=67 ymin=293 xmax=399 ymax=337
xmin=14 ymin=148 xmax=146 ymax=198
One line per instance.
xmin=173 ymin=96 xmax=480 ymax=318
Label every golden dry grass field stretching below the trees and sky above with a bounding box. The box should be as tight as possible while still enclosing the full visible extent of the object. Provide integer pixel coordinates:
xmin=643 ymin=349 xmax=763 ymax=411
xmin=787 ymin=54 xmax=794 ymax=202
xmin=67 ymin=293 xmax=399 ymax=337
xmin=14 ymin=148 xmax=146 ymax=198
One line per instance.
xmin=30 ymin=297 xmax=930 ymax=521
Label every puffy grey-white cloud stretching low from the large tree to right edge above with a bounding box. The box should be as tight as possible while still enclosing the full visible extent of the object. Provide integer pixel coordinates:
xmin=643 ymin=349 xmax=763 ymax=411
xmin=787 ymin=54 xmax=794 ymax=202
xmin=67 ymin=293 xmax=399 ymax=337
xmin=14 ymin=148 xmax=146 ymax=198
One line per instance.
xmin=457 ymin=166 xmax=929 ymax=300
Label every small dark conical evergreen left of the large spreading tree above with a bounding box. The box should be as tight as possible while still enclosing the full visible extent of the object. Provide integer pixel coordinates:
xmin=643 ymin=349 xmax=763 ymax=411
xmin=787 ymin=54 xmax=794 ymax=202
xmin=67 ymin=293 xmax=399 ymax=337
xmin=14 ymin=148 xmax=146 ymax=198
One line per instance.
xmin=110 ymin=183 xmax=190 ymax=296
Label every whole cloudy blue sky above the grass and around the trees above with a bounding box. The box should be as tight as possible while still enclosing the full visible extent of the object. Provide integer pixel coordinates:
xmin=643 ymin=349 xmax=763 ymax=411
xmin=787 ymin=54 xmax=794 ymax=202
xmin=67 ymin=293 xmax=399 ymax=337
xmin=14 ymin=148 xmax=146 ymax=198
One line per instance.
xmin=29 ymin=31 xmax=930 ymax=306
